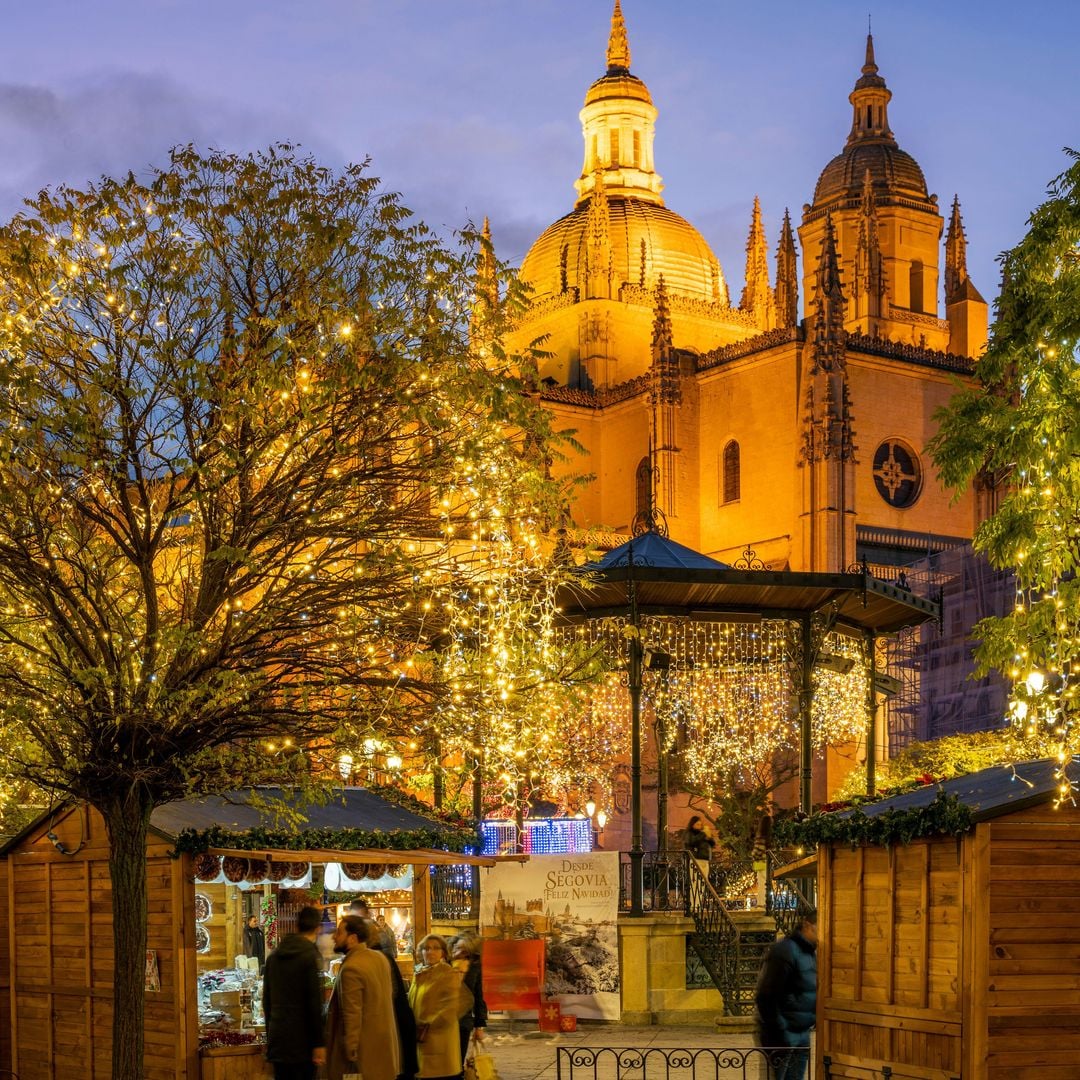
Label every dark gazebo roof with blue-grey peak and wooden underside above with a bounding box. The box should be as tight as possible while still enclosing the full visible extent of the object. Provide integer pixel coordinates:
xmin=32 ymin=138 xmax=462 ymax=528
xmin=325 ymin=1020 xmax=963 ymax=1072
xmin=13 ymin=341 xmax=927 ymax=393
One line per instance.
xmin=559 ymin=532 xmax=941 ymax=634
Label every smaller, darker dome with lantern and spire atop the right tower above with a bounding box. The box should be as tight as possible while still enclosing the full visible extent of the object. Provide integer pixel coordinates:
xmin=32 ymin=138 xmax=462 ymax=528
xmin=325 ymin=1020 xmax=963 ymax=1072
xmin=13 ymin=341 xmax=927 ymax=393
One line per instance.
xmin=812 ymin=35 xmax=936 ymax=212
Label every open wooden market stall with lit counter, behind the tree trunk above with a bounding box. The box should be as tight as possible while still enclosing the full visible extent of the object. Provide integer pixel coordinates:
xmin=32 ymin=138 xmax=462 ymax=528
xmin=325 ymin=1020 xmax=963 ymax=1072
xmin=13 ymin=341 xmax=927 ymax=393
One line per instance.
xmin=0 ymin=787 xmax=507 ymax=1080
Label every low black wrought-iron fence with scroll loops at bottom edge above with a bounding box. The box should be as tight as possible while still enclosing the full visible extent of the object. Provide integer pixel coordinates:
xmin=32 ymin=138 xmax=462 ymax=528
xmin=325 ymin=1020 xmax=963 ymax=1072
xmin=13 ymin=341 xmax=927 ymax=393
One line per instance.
xmin=555 ymin=1047 xmax=787 ymax=1080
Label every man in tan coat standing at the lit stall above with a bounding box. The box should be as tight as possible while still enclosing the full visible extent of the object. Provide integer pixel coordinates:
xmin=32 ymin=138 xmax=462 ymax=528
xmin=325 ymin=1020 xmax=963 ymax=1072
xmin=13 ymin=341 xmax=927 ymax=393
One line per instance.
xmin=325 ymin=915 xmax=401 ymax=1080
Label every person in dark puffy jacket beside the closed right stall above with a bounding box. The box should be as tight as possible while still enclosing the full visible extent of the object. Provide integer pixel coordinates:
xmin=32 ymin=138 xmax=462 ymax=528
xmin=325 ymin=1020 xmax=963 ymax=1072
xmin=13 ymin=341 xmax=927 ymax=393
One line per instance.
xmin=755 ymin=912 xmax=818 ymax=1080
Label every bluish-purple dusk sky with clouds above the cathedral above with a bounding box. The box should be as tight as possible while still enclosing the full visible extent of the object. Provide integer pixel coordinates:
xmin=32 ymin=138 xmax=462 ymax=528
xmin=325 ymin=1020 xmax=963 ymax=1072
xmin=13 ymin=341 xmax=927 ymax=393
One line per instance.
xmin=0 ymin=0 xmax=1080 ymax=299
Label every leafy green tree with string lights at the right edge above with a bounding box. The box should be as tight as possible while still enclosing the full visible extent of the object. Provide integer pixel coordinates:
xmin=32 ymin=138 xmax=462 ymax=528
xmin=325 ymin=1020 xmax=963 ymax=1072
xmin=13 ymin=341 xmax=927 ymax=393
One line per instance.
xmin=930 ymin=150 xmax=1080 ymax=777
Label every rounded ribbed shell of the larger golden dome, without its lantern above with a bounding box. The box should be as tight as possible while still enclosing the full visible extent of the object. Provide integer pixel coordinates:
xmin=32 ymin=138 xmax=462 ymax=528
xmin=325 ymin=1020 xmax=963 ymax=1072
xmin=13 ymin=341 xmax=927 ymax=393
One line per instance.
xmin=521 ymin=197 xmax=727 ymax=301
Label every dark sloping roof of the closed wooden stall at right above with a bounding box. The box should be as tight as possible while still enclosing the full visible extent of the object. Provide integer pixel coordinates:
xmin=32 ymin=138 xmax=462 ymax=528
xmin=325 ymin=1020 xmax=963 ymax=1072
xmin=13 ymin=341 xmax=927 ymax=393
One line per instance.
xmin=840 ymin=758 xmax=1080 ymax=822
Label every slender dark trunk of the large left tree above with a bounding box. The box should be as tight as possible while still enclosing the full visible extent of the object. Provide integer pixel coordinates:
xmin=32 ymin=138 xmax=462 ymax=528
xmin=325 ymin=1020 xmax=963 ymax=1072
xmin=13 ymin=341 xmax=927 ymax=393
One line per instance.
xmin=97 ymin=789 xmax=152 ymax=1080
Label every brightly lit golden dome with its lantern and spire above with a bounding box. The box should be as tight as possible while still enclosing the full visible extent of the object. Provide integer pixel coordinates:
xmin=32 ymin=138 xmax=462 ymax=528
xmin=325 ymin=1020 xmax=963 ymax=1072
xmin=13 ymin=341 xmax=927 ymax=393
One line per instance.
xmin=522 ymin=0 xmax=728 ymax=303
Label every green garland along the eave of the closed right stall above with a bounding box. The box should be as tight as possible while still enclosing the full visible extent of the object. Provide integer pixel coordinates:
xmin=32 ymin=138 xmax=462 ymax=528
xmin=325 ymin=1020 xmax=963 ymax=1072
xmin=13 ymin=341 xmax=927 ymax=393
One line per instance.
xmin=773 ymin=792 xmax=971 ymax=852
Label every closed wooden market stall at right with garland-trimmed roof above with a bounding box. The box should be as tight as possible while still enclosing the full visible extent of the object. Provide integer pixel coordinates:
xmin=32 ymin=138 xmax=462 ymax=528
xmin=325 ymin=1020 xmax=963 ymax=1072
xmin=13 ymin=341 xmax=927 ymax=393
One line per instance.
xmin=816 ymin=760 xmax=1080 ymax=1080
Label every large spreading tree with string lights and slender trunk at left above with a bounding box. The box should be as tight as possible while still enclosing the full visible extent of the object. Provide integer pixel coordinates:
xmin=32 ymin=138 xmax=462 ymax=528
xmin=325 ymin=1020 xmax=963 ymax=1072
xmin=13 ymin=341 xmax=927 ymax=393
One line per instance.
xmin=0 ymin=147 xmax=561 ymax=1080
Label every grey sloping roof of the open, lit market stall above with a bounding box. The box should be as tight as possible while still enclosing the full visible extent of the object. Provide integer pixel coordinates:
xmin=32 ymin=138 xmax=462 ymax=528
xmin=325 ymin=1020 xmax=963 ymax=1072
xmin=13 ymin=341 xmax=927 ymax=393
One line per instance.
xmin=150 ymin=786 xmax=518 ymax=866
